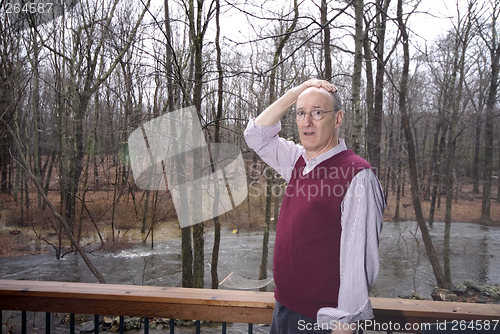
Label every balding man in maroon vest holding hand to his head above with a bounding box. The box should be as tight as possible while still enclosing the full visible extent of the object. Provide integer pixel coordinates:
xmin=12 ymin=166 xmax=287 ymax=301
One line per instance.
xmin=245 ymin=79 xmax=385 ymax=334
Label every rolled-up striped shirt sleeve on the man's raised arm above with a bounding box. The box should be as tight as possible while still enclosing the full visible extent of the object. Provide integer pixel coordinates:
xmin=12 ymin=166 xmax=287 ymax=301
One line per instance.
xmin=244 ymin=119 xmax=303 ymax=182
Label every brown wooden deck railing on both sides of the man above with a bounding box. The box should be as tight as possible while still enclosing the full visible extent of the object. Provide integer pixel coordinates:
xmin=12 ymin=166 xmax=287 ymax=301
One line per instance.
xmin=0 ymin=280 xmax=500 ymax=332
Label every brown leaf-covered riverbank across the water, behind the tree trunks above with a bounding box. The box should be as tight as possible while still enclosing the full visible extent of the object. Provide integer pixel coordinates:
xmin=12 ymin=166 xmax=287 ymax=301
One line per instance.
xmin=0 ymin=183 xmax=500 ymax=257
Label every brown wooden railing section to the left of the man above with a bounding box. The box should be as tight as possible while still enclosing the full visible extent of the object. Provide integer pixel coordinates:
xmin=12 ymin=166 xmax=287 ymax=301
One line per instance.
xmin=0 ymin=280 xmax=274 ymax=323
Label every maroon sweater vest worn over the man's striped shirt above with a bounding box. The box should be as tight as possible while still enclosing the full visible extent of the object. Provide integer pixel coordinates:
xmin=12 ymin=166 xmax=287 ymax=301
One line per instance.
xmin=273 ymin=150 xmax=371 ymax=319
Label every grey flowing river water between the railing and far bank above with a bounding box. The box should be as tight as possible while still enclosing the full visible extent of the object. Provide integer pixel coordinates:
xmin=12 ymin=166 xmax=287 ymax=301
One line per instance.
xmin=0 ymin=222 xmax=500 ymax=333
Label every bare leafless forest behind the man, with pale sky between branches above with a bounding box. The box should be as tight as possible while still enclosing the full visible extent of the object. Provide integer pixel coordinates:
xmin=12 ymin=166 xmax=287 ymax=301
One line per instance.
xmin=0 ymin=0 xmax=500 ymax=288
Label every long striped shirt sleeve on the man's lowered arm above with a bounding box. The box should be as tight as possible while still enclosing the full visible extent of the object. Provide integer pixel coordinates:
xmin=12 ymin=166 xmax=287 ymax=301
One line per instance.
xmin=317 ymin=169 xmax=386 ymax=324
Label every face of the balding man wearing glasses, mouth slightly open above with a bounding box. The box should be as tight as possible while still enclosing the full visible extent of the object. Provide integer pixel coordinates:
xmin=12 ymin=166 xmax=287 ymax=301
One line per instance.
xmin=297 ymin=87 xmax=343 ymax=159
